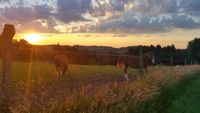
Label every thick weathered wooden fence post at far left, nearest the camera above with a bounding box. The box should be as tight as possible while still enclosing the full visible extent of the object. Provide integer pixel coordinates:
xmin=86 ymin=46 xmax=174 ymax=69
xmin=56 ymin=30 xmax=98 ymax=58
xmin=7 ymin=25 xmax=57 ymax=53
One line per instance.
xmin=0 ymin=24 xmax=15 ymax=94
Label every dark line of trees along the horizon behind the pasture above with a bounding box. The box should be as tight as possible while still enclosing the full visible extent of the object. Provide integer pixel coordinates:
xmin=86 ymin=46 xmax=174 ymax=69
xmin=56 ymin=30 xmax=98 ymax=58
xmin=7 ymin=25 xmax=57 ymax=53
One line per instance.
xmin=0 ymin=38 xmax=200 ymax=65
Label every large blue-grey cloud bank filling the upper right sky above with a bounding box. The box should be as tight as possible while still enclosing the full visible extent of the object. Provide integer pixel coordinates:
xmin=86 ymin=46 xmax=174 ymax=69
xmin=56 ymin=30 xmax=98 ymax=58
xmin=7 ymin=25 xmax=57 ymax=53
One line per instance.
xmin=95 ymin=0 xmax=200 ymax=33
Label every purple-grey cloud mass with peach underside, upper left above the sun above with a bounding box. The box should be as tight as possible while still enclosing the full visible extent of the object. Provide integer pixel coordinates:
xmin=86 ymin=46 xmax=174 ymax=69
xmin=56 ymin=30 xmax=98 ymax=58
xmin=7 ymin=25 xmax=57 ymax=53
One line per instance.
xmin=0 ymin=0 xmax=91 ymax=32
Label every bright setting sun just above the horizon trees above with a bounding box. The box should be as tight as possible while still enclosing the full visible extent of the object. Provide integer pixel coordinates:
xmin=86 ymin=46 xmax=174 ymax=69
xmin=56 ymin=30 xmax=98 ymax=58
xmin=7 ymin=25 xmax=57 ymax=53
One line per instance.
xmin=24 ymin=34 xmax=41 ymax=44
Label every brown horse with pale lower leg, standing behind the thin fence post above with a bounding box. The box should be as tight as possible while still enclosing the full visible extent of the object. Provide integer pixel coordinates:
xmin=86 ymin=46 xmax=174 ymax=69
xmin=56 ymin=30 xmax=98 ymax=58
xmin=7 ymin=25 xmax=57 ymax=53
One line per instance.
xmin=117 ymin=53 xmax=155 ymax=80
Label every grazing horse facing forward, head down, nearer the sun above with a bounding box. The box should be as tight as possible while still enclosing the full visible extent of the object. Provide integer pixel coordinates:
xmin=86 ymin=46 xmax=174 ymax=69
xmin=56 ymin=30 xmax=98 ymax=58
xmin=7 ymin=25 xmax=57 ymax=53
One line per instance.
xmin=54 ymin=54 xmax=69 ymax=78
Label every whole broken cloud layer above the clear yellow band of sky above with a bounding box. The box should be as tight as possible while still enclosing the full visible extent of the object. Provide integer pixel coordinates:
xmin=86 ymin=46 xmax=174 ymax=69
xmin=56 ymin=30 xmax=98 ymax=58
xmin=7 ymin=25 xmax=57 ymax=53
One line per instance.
xmin=0 ymin=0 xmax=200 ymax=33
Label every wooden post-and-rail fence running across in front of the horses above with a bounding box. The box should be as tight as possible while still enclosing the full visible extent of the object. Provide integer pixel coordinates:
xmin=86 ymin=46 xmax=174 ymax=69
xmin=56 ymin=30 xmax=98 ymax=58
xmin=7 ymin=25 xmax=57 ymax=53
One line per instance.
xmin=0 ymin=25 xmax=197 ymax=93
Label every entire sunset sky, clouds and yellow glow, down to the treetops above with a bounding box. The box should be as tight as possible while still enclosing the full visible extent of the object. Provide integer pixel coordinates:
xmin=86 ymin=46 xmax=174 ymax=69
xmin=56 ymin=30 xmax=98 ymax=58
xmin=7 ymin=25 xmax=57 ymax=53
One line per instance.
xmin=0 ymin=0 xmax=200 ymax=48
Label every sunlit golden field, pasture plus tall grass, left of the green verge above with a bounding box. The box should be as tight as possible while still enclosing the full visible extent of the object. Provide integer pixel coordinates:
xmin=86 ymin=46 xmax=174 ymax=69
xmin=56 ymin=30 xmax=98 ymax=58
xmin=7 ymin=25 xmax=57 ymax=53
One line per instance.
xmin=0 ymin=62 xmax=200 ymax=113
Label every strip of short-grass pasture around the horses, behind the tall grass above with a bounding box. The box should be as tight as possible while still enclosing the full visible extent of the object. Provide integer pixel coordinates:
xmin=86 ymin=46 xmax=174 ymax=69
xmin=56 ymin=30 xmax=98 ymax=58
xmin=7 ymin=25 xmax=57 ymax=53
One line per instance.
xmin=0 ymin=62 xmax=138 ymax=82
